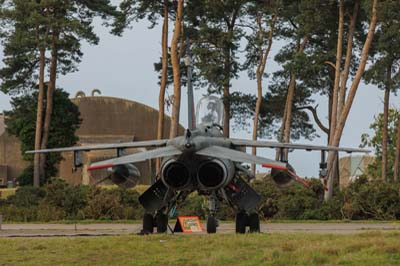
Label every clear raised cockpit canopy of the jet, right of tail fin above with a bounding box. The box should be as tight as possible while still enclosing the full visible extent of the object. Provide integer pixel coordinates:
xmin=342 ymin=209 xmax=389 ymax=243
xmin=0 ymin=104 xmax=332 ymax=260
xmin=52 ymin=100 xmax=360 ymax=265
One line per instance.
xmin=196 ymin=96 xmax=225 ymax=127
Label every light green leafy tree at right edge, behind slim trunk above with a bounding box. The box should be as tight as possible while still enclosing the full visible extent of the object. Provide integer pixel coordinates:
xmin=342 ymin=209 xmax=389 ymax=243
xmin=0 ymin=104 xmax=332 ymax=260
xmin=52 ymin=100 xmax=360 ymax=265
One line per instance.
xmin=361 ymin=109 xmax=399 ymax=180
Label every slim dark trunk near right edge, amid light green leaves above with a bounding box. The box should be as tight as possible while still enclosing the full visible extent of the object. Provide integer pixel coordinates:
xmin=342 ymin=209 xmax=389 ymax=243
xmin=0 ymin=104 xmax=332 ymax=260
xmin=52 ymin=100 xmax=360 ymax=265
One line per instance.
xmin=381 ymin=81 xmax=390 ymax=182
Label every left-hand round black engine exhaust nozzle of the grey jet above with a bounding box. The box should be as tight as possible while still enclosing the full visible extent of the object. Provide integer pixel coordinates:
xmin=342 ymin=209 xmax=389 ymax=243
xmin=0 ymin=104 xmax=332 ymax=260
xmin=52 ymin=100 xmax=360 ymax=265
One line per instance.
xmin=161 ymin=159 xmax=191 ymax=190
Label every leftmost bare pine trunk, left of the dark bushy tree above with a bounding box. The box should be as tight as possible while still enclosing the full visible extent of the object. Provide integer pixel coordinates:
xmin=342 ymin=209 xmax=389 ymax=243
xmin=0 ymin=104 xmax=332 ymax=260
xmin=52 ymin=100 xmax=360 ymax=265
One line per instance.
xmin=33 ymin=47 xmax=46 ymax=187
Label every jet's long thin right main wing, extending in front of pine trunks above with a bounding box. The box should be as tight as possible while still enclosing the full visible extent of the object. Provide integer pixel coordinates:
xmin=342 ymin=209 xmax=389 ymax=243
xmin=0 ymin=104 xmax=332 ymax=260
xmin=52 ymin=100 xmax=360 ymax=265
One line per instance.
xmin=231 ymin=139 xmax=371 ymax=153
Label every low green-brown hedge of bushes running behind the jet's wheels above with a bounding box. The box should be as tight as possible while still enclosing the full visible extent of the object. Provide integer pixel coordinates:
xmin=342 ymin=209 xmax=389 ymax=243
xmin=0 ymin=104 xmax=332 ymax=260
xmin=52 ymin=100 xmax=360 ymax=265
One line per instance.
xmin=0 ymin=177 xmax=400 ymax=222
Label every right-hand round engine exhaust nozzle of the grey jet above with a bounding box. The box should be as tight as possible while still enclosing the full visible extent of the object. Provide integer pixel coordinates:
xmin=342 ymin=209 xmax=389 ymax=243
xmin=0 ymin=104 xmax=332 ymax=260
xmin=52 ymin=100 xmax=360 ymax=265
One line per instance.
xmin=197 ymin=159 xmax=235 ymax=190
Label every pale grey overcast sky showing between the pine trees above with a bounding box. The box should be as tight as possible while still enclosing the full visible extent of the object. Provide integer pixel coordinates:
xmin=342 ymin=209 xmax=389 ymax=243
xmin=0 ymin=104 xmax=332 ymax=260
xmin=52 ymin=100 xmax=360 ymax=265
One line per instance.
xmin=0 ymin=11 xmax=400 ymax=177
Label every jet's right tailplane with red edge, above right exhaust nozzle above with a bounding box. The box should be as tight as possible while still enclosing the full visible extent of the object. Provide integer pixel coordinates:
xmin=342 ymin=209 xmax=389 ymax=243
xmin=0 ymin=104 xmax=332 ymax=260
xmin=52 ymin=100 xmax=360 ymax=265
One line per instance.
xmin=196 ymin=146 xmax=287 ymax=170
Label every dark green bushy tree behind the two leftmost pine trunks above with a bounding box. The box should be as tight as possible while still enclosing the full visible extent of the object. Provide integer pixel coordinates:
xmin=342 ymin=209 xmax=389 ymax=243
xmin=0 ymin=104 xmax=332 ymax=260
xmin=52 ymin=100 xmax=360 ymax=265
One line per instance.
xmin=4 ymin=89 xmax=81 ymax=185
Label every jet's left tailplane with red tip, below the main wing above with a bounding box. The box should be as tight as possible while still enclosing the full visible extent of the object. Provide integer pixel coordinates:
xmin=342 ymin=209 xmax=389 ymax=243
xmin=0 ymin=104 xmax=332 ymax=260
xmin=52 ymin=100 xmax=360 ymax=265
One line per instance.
xmin=88 ymin=146 xmax=182 ymax=171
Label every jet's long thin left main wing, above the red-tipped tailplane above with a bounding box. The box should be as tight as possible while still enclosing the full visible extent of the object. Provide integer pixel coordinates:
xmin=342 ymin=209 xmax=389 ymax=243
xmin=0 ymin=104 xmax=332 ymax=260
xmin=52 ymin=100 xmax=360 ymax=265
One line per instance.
xmin=26 ymin=139 xmax=168 ymax=153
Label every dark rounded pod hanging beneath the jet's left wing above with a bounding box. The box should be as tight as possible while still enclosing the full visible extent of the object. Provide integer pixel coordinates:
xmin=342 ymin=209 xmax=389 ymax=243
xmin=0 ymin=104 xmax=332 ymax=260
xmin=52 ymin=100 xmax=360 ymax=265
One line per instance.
xmin=110 ymin=164 xmax=140 ymax=188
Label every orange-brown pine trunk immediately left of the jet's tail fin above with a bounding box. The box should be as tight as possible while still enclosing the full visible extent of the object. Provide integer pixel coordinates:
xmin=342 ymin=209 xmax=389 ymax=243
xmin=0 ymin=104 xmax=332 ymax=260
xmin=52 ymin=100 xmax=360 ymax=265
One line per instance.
xmin=169 ymin=0 xmax=184 ymax=138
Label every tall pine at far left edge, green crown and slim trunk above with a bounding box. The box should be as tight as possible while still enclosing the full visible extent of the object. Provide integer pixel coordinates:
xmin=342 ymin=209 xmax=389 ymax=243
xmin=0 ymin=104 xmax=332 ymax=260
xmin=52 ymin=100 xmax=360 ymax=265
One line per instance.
xmin=0 ymin=1 xmax=49 ymax=186
